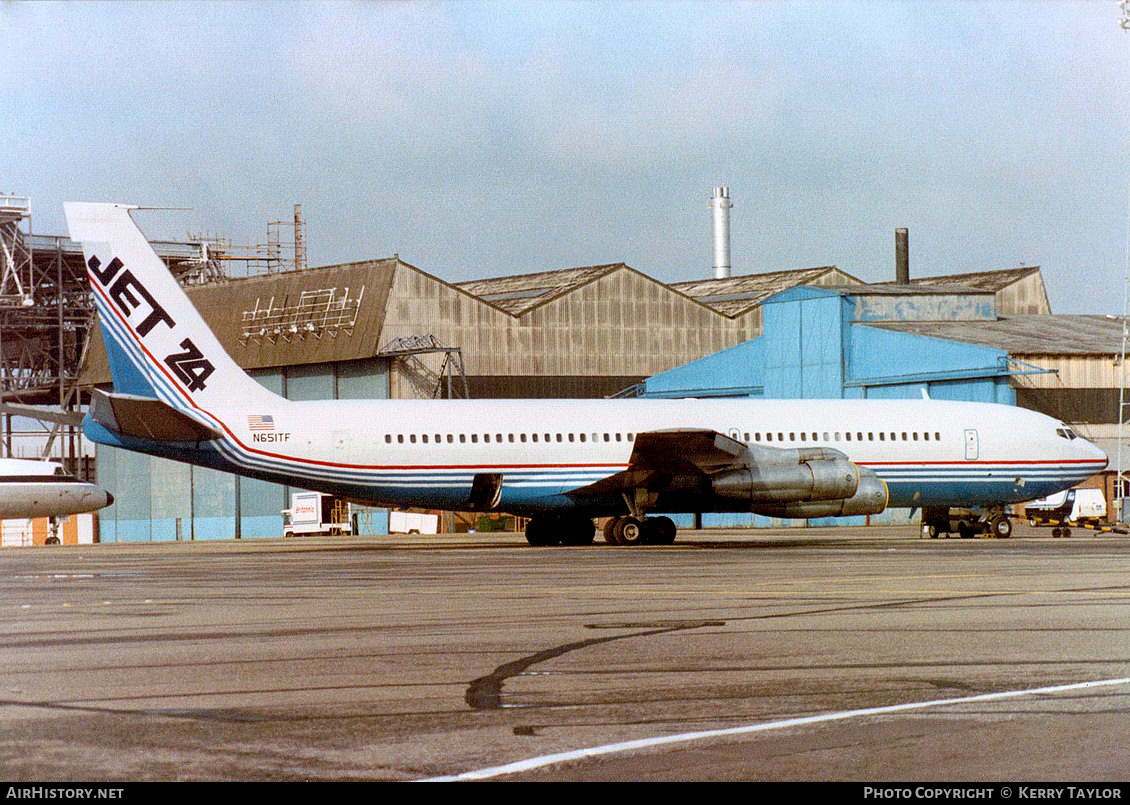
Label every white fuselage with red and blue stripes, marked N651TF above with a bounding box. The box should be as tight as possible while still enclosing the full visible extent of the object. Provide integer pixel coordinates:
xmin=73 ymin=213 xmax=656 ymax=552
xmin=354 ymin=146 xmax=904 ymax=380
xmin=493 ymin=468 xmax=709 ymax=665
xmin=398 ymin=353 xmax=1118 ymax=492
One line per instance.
xmin=123 ymin=399 xmax=1106 ymax=511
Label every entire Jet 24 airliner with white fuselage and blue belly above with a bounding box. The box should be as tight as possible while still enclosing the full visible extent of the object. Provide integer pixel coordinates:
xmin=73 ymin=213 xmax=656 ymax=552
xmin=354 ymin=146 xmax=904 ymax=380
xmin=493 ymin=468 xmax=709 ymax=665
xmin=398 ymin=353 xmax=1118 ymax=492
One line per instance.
xmin=66 ymin=204 xmax=1106 ymax=545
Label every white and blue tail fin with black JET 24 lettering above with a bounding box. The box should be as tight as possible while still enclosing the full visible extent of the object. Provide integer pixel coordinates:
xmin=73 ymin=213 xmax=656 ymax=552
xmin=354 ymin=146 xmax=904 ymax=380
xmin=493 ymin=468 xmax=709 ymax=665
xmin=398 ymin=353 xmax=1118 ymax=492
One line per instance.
xmin=64 ymin=202 xmax=278 ymax=426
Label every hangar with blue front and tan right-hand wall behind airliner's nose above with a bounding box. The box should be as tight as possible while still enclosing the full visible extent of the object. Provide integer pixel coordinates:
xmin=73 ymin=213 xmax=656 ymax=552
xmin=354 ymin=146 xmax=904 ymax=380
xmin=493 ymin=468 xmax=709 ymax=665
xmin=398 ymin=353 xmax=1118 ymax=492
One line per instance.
xmin=638 ymin=268 xmax=1122 ymax=526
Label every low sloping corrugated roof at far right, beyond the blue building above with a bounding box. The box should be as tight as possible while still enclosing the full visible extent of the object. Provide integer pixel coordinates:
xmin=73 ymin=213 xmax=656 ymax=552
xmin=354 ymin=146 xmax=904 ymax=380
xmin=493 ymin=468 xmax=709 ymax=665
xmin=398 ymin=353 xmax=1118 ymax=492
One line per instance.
xmin=862 ymin=313 xmax=1122 ymax=355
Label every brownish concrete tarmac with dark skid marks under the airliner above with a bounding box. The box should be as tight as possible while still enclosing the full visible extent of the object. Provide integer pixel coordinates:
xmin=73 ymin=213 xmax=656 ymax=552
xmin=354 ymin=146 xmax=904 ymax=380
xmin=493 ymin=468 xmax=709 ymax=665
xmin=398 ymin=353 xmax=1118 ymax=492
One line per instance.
xmin=0 ymin=525 xmax=1130 ymax=782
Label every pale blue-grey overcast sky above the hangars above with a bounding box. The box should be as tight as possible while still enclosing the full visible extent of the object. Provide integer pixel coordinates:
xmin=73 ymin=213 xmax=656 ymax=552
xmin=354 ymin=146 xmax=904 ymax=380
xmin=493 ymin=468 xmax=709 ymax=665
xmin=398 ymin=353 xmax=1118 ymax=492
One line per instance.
xmin=0 ymin=0 xmax=1130 ymax=313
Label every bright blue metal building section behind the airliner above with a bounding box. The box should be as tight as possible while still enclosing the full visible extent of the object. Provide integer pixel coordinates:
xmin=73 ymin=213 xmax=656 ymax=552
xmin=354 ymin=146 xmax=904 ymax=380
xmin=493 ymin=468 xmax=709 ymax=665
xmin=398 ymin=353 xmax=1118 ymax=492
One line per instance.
xmin=641 ymin=285 xmax=1026 ymax=527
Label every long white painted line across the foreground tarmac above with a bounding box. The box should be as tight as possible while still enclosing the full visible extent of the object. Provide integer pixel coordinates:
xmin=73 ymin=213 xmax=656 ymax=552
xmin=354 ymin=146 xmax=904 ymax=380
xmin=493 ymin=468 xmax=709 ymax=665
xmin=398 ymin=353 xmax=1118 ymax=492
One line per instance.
xmin=420 ymin=677 xmax=1130 ymax=782
